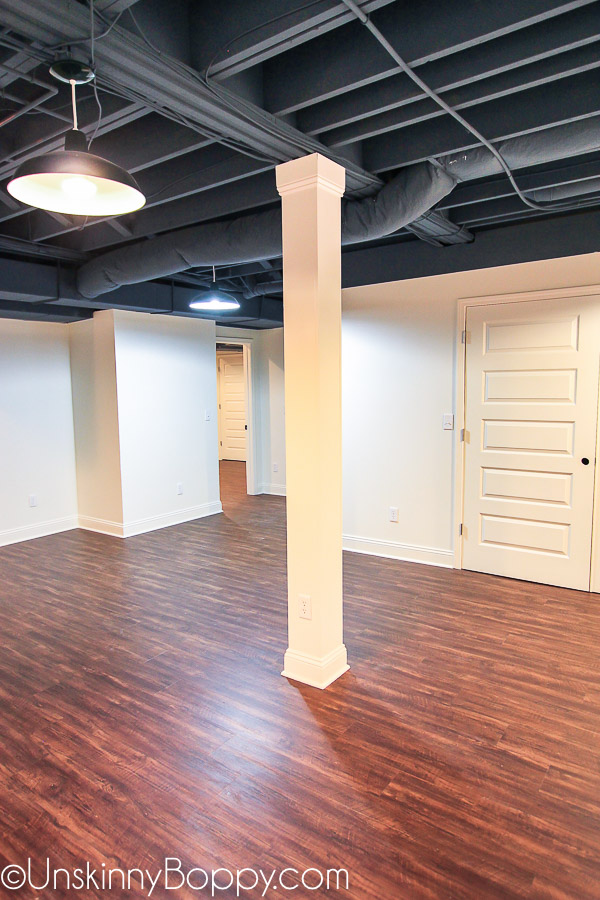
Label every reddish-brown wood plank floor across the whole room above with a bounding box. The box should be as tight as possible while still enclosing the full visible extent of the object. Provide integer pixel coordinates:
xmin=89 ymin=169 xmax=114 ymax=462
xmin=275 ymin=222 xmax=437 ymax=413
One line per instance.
xmin=0 ymin=463 xmax=600 ymax=900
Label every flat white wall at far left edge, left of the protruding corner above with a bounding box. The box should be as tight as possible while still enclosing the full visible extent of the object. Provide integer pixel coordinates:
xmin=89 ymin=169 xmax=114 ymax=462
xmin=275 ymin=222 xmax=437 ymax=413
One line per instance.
xmin=0 ymin=319 xmax=77 ymax=544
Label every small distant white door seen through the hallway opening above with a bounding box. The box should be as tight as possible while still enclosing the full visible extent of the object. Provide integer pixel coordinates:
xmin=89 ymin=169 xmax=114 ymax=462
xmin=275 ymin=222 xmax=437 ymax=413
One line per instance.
xmin=218 ymin=350 xmax=247 ymax=460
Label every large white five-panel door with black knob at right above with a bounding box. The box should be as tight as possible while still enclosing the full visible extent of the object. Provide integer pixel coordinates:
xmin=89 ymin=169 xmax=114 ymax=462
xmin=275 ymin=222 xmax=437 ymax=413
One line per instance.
xmin=463 ymin=298 xmax=600 ymax=590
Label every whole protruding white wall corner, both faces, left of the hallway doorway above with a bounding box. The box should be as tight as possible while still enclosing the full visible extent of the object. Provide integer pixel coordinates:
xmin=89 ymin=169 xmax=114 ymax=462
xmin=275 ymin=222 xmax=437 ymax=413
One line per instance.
xmin=71 ymin=310 xmax=222 ymax=537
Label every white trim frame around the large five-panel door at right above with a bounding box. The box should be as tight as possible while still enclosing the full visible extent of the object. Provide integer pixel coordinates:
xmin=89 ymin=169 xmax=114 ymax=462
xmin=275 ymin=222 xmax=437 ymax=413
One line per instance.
xmin=453 ymin=284 xmax=600 ymax=572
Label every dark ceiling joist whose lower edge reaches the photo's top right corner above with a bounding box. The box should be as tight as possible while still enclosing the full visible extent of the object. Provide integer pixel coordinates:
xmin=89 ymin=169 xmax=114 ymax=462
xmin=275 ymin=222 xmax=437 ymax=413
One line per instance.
xmin=264 ymin=0 xmax=593 ymax=114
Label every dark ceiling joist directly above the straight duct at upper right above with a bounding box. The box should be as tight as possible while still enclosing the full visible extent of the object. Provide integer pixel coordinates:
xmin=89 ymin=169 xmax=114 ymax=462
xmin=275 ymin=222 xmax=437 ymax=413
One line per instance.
xmin=363 ymin=72 xmax=600 ymax=172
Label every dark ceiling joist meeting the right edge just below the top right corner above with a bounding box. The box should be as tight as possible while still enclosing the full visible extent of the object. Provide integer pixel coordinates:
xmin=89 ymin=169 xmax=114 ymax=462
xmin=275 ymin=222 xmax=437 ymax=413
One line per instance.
xmin=296 ymin=6 xmax=600 ymax=134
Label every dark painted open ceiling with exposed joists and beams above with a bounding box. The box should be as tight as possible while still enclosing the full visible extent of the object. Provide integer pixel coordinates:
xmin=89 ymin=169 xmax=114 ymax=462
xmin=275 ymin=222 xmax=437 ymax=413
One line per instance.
xmin=0 ymin=0 xmax=600 ymax=327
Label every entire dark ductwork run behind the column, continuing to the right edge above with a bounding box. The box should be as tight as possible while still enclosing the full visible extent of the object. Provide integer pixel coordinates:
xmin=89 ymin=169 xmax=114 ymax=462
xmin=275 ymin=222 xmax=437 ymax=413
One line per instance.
xmin=77 ymin=118 xmax=600 ymax=299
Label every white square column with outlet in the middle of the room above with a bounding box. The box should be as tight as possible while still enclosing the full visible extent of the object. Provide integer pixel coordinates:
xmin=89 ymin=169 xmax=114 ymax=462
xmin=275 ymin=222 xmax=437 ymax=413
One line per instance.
xmin=277 ymin=153 xmax=348 ymax=688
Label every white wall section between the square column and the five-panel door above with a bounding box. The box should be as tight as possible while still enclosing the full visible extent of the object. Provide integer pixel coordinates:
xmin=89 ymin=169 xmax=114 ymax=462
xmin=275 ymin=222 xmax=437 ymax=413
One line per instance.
xmin=342 ymin=282 xmax=456 ymax=563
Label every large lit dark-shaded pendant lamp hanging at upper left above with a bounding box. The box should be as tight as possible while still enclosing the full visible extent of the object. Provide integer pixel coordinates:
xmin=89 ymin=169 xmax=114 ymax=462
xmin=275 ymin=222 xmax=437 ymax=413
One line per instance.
xmin=6 ymin=59 xmax=146 ymax=216
